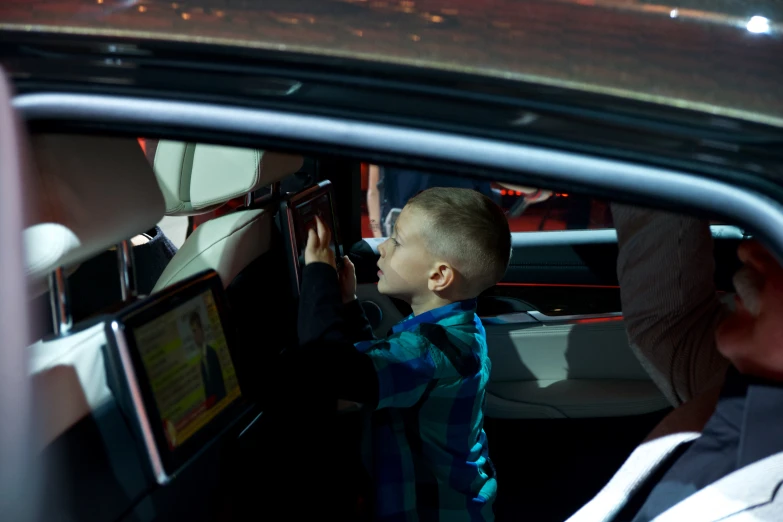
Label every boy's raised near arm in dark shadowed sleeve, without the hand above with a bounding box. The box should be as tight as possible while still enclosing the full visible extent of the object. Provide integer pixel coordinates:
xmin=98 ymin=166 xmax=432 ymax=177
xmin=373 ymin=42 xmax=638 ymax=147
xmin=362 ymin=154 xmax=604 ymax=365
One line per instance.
xmin=288 ymin=263 xmax=438 ymax=409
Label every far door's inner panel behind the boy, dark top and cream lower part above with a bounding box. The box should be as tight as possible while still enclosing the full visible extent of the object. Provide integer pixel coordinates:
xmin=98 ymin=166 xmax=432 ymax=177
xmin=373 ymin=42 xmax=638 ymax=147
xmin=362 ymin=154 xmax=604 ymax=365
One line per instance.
xmin=480 ymin=226 xmax=743 ymax=419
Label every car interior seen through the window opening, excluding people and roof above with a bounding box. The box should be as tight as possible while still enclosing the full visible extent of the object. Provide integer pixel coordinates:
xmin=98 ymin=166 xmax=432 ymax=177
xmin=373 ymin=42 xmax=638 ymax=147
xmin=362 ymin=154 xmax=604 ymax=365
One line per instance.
xmin=16 ymin=123 xmax=745 ymax=522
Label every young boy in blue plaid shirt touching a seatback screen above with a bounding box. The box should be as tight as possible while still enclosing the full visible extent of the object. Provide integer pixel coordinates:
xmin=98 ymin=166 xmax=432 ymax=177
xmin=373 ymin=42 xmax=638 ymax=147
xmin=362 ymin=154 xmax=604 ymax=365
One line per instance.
xmin=272 ymin=188 xmax=511 ymax=522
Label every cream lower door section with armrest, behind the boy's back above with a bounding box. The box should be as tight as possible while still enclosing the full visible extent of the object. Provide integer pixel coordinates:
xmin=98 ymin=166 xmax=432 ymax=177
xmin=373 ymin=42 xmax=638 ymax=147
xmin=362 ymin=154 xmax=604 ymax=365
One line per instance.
xmin=485 ymin=317 xmax=668 ymax=419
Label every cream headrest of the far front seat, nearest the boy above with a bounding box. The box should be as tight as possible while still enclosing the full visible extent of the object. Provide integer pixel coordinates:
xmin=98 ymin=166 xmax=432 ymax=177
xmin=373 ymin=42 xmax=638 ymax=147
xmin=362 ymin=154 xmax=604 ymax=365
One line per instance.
xmin=154 ymin=140 xmax=304 ymax=216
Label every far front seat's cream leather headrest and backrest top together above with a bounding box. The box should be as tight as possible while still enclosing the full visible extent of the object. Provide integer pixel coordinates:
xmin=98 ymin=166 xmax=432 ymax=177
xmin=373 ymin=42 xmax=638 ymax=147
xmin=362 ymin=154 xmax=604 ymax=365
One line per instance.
xmin=153 ymin=141 xmax=303 ymax=291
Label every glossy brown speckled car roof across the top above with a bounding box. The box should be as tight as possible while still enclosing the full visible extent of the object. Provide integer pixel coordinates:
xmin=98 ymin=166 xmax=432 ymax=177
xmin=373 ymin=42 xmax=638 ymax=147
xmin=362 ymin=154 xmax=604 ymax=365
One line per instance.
xmin=0 ymin=0 xmax=783 ymax=126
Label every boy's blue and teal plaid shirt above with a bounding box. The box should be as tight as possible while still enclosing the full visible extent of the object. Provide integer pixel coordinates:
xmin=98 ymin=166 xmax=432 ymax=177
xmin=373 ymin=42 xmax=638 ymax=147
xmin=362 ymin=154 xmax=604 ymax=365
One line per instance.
xmin=356 ymin=299 xmax=497 ymax=522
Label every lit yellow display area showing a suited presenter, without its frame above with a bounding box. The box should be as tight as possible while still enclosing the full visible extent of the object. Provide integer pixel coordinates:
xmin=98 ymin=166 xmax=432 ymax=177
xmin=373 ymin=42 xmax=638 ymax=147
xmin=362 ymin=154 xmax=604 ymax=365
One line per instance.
xmin=133 ymin=290 xmax=241 ymax=450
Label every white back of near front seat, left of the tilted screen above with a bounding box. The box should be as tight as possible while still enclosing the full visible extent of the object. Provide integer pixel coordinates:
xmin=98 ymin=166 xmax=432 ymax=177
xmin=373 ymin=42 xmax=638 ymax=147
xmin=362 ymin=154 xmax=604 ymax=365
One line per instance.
xmin=28 ymin=322 xmax=112 ymax=447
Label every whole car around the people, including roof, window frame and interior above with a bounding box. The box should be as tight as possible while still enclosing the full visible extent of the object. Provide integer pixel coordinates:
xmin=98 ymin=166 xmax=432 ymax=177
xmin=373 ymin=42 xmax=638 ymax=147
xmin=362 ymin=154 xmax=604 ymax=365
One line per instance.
xmin=0 ymin=0 xmax=783 ymax=512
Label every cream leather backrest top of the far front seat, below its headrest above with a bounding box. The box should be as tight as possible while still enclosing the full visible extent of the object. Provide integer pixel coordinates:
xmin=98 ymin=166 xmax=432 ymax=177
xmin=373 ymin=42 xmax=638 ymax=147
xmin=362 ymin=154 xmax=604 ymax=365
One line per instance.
xmin=153 ymin=209 xmax=275 ymax=292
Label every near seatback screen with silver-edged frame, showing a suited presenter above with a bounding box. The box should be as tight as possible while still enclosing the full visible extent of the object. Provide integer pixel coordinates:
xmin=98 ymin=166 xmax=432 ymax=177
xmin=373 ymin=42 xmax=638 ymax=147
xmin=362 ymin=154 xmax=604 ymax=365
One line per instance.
xmin=107 ymin=270 xmax=248 ymax=484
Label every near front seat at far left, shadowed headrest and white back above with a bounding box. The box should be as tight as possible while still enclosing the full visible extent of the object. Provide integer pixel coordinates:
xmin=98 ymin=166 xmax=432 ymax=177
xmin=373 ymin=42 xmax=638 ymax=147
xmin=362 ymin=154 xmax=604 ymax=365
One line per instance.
xmin=24 ymin=135 xmax=165 ymax=448
